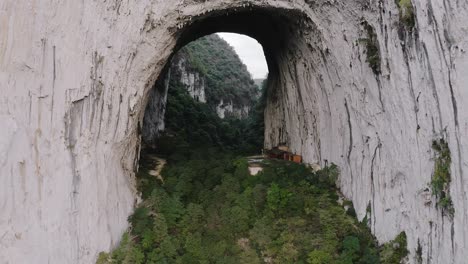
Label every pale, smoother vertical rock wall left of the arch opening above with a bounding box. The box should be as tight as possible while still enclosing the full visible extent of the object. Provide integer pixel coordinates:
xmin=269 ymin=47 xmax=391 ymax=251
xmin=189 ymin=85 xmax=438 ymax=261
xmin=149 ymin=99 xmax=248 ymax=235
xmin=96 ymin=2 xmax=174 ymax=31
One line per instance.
xmin=0 ymin=0 xmax=175 ymax=264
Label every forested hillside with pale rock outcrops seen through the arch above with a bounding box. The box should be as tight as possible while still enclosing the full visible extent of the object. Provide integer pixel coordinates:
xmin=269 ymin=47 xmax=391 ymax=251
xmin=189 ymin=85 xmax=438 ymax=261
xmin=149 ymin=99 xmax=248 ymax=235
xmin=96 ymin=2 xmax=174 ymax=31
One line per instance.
xmin=142 ymin=34 xmax=264 ymax=146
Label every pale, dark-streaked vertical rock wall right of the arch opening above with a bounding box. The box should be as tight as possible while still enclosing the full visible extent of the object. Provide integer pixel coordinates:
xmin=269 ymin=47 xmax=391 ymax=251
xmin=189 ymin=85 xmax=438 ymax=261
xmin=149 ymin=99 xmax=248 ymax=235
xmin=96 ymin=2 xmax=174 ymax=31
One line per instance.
xmin=265 ymin=1 xmax=468 ymax=263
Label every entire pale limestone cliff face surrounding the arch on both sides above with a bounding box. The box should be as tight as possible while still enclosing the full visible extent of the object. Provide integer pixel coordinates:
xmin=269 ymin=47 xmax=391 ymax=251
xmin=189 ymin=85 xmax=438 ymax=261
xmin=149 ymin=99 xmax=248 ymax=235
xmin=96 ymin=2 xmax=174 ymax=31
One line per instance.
xmin=0 ymin=0 xmax=468 ymax=263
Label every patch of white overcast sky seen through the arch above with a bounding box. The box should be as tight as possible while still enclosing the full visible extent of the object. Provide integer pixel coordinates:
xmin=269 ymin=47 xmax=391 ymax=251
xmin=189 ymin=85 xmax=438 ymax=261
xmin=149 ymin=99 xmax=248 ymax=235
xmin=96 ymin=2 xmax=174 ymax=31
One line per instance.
xmin=218 ymin=33 xmax=268 ymax=79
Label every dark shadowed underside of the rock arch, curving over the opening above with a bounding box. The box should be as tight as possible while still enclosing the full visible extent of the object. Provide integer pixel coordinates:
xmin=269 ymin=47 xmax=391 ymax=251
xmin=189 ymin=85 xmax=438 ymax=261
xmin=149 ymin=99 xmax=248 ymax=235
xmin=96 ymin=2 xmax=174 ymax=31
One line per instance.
xmin=141 ymin=6 xmax=312 ymax=146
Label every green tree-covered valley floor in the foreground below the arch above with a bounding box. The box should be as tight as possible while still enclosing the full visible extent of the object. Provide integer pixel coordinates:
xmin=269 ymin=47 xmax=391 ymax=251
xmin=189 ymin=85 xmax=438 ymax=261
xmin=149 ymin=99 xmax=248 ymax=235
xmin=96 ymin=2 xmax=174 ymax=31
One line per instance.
xmin=97 ymin=148 xmax=407 ymax=264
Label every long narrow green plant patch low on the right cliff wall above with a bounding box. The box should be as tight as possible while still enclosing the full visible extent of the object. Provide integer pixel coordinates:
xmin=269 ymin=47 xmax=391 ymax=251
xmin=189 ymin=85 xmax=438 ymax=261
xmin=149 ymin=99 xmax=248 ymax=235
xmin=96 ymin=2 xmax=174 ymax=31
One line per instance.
xmin=431 ymin=138 xmax=455 ymax=217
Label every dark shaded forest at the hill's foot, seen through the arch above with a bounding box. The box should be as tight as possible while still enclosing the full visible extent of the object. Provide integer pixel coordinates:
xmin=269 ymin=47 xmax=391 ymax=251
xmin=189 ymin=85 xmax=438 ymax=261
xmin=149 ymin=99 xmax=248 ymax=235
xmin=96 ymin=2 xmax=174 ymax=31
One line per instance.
xmin=157 ymin=76 xmax=266 ymax=156
